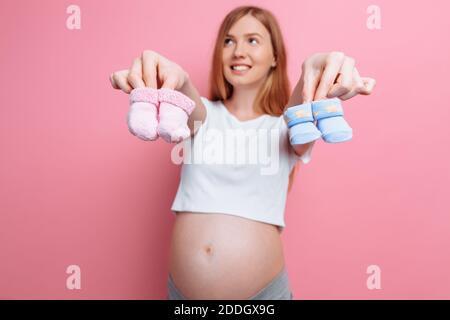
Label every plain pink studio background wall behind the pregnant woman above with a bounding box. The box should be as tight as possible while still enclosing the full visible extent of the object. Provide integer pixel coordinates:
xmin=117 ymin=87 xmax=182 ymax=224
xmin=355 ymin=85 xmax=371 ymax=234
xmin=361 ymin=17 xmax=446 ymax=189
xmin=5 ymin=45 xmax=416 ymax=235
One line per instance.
xmin=0 ymin=0 xmax=450 ymax=299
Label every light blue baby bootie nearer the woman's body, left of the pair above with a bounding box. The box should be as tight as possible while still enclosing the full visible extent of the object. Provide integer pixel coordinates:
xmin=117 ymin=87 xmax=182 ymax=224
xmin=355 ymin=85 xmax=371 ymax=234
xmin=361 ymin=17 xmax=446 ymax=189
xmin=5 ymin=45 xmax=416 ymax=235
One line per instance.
xmin=283 ymin=102 xmax=322 ymax=145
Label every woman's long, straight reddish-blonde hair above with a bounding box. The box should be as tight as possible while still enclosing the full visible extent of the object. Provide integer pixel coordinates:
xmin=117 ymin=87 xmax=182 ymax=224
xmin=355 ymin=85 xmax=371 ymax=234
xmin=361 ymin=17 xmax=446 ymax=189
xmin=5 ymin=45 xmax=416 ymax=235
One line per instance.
xmin=208 ymin=6 xmax=297 ymax=192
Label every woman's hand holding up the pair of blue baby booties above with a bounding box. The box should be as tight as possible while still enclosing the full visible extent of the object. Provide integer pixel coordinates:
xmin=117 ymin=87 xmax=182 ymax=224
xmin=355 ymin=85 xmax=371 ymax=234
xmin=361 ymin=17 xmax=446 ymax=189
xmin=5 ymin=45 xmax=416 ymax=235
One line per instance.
xmin=299 ymin=51 xmax=376 ymax=102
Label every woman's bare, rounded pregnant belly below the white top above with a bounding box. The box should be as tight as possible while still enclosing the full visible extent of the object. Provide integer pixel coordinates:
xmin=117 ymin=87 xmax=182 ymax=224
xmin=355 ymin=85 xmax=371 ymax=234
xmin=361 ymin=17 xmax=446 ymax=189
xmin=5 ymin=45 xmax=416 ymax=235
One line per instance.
xmin=169 ymin=212 xmax=284 ymax=299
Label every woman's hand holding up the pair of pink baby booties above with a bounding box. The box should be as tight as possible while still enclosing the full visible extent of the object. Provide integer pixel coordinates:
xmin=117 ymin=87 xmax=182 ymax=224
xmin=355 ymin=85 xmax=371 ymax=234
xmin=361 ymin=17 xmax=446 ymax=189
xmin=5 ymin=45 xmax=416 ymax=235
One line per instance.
xmin=110 ymin=50 xmax=189 ymax=93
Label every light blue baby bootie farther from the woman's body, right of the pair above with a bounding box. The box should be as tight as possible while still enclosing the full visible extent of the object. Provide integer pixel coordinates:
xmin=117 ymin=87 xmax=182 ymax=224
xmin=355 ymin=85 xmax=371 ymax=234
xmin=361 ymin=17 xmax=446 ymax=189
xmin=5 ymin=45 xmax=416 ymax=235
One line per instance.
xmin=311 ymin=98 xmax=353 ymax=143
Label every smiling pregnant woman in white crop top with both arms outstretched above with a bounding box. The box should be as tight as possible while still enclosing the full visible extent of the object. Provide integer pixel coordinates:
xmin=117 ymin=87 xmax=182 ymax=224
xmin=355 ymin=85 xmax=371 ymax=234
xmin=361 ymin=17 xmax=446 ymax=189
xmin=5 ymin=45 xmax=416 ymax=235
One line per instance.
xmin=110 ymin=6 xmax=375 ymax=300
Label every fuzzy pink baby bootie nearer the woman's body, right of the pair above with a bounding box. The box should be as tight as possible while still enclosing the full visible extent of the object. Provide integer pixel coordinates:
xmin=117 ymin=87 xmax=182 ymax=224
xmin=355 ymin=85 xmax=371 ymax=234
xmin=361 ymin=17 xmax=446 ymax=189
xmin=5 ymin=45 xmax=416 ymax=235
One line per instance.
xmin=157 ymin=88 xmax=195 ymax=143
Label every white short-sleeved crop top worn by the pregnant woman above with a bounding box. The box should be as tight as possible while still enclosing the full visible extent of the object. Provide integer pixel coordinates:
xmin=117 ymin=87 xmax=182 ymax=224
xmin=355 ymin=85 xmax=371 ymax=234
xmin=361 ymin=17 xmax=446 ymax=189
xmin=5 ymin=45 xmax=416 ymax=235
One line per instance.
xmin=171 ymin=97 xmax=312 ymax=230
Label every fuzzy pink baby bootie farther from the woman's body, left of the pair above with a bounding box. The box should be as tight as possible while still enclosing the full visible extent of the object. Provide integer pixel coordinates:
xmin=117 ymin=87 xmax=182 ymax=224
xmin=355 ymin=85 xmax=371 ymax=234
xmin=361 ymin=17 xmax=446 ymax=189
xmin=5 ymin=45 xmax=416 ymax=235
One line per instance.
xmin=127 ymin=87 xmax=159 ymax=141
